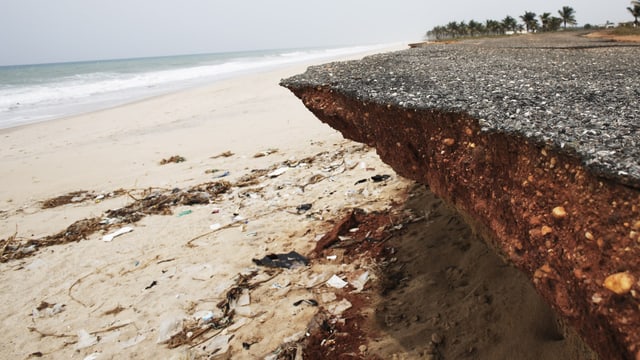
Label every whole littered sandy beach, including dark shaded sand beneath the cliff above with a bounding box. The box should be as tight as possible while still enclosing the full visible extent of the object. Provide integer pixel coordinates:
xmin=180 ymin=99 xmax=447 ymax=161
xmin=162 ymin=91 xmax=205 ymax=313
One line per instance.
xmin=0 ymin=45 xmax=596 ymax=359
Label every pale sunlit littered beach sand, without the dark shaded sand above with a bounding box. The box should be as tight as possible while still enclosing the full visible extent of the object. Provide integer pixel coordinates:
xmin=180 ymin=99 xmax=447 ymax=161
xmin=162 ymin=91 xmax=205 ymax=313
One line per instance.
xmin=0 ymin=49 xmax=420 ymax=359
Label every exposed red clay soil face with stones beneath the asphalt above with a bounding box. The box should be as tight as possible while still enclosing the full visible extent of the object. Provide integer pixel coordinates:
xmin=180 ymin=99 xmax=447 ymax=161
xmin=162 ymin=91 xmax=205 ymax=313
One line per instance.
xmin=296 ymin=88 xmax=640 ymax=359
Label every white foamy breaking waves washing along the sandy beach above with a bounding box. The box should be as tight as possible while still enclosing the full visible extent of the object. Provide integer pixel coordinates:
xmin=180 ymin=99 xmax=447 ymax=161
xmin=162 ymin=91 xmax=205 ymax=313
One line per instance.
xmin=0 ymin=45 xmax=396 ymax=128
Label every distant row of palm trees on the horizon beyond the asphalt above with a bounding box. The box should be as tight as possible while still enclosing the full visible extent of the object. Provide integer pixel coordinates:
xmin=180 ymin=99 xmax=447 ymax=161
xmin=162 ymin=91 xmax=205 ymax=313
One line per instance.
xmin=426 ymin=6 xmax=584 ymax=40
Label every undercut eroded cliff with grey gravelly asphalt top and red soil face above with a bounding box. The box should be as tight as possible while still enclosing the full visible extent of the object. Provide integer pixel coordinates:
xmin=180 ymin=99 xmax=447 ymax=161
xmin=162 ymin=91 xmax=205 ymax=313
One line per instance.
xmin=282 ymin=35 xmax=640 ymax=359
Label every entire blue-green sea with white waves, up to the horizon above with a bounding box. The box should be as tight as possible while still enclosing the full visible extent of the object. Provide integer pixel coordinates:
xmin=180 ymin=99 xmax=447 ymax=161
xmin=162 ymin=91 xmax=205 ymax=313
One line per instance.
xmin=0 ymin=45 xmax=384 ymax=128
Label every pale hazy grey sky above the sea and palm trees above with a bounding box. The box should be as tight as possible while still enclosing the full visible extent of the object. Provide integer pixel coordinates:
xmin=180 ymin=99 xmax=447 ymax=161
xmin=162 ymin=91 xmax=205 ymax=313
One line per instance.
xmin=0 ymin=0 xmax=633 ymax=65
